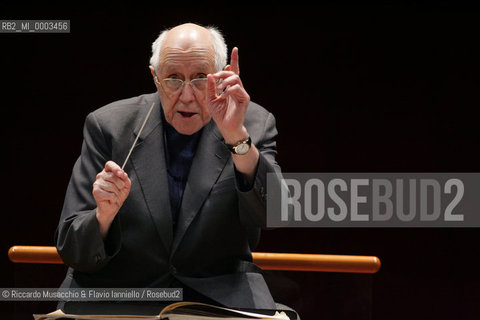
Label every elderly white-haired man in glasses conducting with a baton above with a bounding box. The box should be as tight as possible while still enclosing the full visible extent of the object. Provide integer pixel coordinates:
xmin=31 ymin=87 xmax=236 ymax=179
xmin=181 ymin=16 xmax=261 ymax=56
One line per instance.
xmin=55 ymin=24 xmax=290 ymax=316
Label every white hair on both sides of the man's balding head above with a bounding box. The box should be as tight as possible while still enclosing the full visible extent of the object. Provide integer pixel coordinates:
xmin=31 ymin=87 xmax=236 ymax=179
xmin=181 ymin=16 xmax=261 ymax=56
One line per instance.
xmin=150 ymin=26 xmax=227 ymax=71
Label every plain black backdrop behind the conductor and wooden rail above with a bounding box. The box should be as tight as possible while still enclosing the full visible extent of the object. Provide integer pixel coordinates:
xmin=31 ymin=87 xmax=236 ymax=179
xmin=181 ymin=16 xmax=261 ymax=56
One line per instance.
xmin=0 ymin=1 xmax=480 ymax=320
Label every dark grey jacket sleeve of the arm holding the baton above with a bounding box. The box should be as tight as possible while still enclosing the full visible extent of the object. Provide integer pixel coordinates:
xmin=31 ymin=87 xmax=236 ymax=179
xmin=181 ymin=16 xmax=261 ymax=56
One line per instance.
xmin=55 ymin=113 xmax=121 ymax=272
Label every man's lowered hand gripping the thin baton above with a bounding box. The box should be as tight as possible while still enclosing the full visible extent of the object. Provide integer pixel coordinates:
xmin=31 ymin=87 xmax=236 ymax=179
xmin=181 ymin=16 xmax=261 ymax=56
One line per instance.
xmin=92 ymin=161 xmax=131 ymax=239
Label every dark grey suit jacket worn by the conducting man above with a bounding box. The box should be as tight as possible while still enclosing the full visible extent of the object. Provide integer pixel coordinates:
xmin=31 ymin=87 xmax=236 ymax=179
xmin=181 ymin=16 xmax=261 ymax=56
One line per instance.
xmin=55 ymin=93 xmax=280 ymax=309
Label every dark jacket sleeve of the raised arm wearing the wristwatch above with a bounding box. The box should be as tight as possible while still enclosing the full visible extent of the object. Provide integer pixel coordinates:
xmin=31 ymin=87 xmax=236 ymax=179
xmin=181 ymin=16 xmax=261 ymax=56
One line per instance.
xmin=236 ymin=113 xmax=284 ymax=229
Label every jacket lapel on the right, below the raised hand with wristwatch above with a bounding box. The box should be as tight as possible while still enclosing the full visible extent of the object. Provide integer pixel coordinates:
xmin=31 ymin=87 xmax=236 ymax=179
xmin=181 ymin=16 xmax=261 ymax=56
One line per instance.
xmin=171 ymin=120 xmax=230 ymax=255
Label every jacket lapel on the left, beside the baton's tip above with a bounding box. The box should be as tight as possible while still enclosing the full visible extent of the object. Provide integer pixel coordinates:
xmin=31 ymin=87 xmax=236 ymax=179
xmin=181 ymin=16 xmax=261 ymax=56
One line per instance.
xmin=131 ymin=95 xmax=173 ymax=251
